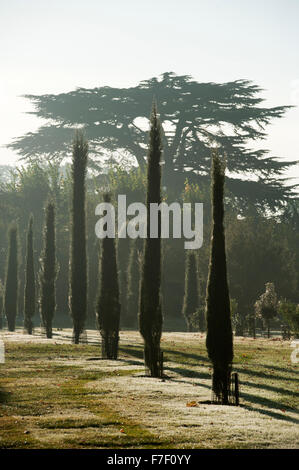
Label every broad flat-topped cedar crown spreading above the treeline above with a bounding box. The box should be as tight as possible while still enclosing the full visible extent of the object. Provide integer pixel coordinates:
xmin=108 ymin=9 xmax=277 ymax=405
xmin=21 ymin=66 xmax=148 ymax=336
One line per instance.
xmin=9 ymin=72 xmax=295 ymax=210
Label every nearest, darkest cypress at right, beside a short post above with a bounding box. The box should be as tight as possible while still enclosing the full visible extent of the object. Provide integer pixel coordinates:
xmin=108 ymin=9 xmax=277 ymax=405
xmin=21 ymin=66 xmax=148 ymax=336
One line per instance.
xmin=206 ymin=151 xmax=233 ymax=404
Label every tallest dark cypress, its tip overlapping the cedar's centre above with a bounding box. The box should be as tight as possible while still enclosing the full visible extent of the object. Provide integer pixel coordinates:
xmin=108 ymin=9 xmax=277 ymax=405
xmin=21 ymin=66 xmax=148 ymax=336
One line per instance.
xmin=139 ymin=104 xmax=163 ymax=377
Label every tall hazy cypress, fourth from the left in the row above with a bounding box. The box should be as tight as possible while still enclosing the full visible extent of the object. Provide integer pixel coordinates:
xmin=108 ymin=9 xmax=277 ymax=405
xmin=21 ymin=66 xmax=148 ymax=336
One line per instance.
xmin=70 ymin=131 xmax=88 ymax=344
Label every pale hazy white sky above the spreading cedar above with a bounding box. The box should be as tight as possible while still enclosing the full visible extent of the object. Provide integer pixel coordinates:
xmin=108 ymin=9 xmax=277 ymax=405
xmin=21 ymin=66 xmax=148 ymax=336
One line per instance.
xmin=0 ymin=0 xmax=299 ymax=177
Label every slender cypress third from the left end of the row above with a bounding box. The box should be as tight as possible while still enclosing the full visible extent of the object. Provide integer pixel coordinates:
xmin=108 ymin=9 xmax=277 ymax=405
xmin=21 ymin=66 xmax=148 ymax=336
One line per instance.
xmin=40 ymin=202 xmax=57 ymax=338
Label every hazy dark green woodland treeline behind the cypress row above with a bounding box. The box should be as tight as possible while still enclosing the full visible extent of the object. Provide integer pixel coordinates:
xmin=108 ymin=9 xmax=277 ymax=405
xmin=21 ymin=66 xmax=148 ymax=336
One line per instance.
xmin=0 ymin=162 xmax=299 ymax=333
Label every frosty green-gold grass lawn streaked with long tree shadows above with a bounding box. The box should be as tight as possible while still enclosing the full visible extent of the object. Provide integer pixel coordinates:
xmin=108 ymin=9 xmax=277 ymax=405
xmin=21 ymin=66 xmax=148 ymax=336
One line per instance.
xmin=0 ymin=329 xmax=299 ymax=449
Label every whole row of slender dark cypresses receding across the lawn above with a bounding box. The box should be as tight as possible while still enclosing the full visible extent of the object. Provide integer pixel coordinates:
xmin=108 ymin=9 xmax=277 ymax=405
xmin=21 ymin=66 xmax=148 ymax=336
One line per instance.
xmin=0 ymin=104 xmax=233 ymax=404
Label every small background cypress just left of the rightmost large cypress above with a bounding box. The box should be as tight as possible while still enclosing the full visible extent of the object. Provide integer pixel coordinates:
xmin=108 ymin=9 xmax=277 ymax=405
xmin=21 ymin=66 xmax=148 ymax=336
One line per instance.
xmin=183 ymin=250 xmax=199 ymax=331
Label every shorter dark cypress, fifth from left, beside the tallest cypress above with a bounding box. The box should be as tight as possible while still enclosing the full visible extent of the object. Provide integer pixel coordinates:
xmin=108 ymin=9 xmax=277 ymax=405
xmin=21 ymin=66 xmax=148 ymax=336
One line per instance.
xmin=97 ymin=194 xmax=120 ymax=359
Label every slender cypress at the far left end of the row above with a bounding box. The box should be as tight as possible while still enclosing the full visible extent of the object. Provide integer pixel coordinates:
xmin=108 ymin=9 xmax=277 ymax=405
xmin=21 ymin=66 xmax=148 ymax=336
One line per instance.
xmin=4 ymin=225 xmax=19 ymax=331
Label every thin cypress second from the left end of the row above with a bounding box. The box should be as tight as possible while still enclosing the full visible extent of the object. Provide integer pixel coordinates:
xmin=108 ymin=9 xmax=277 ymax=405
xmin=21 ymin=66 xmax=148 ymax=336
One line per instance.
xmin=24 ymin=214 xmax=35 ymax=335
